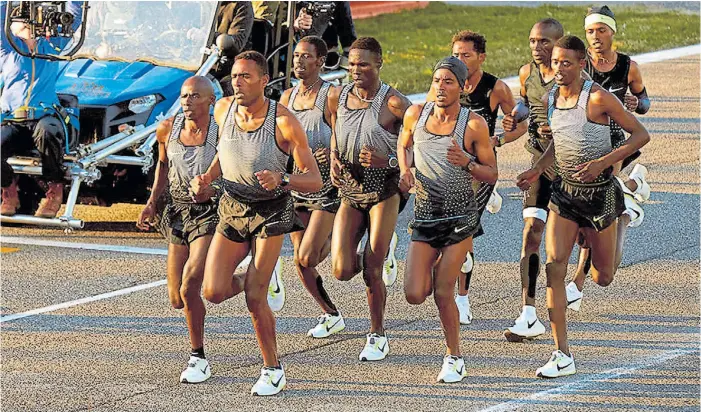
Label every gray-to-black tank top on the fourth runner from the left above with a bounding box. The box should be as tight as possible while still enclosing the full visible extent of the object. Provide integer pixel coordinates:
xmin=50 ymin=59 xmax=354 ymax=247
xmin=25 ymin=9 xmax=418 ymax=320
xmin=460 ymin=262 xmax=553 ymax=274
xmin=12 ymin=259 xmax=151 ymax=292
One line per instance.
xmin=336 ymin=83 xmax=399 ymax=194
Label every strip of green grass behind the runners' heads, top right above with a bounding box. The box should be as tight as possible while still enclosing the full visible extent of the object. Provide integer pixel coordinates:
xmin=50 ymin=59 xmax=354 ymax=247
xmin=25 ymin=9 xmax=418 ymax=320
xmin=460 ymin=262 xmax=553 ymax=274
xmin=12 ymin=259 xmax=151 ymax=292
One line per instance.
xmin=355 ymin=2 xmax=700 ymax=94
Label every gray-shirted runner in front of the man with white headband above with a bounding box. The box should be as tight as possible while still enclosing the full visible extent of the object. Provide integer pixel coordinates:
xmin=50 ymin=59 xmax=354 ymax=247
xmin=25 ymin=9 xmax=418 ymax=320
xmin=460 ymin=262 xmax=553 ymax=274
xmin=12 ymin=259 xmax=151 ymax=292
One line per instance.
xmin=517 ymin=36 xmax=650 ymax=378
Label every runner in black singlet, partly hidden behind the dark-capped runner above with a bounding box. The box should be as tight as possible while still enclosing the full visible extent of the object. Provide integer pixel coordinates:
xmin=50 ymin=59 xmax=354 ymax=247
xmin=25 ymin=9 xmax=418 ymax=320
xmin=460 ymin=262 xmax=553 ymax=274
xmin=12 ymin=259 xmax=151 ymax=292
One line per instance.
xmin=427 ymin=30 xmax=526 ymax=325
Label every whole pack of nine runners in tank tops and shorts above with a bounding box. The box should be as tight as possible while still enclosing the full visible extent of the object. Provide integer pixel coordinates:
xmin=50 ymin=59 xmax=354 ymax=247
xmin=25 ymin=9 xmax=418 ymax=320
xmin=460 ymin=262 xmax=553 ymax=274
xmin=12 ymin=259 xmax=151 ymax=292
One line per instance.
xmin=137 ymin=6 xmax=650 ymax=395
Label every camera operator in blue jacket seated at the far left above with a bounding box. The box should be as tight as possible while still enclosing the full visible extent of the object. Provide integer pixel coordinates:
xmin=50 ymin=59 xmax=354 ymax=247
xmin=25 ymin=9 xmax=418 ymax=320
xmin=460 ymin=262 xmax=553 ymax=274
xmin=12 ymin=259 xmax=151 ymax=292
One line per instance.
xmin=0 ymin=2 xmax=82 ymax=218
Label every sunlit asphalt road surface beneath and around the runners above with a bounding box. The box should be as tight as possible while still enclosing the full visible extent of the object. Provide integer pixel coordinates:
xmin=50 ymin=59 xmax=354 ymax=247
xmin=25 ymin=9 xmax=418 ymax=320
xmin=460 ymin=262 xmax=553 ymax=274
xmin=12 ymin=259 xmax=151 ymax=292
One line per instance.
xmin=0 ymin=56 xmax=701 ymax=412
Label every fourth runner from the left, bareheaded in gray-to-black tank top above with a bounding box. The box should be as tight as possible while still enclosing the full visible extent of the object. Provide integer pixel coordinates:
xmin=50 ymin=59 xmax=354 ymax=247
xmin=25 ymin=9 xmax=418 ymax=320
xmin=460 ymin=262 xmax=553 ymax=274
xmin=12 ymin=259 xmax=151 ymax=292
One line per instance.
xmin=329 ymin=37 xmax=411 ymax=361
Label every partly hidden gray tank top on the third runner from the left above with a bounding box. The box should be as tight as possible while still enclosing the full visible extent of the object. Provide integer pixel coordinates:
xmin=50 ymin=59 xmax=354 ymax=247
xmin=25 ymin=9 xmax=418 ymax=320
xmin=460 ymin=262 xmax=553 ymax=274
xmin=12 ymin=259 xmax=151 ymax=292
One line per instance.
xmin=288 ymin=82 xmax=334 ymax=200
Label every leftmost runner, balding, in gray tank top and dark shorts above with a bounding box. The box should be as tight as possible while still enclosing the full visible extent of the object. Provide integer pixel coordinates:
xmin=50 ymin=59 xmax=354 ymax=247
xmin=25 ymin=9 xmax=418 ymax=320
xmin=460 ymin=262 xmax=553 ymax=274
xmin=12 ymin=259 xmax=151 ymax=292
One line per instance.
xmin=136 ymin=76 xmax=219 ymax=383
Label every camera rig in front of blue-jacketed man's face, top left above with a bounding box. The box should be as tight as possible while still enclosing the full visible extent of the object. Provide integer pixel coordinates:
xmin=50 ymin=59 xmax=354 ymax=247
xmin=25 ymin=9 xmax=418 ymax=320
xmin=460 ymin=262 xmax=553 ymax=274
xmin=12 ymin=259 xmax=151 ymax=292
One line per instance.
xmin=10 ymin=1 xmax=75 ymax=38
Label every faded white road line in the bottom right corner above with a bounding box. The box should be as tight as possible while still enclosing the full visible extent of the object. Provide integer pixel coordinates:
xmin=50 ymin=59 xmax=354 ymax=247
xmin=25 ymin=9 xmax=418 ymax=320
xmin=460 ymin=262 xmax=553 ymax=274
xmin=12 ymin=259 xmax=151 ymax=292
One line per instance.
xmin=481 ymin=350 xmax=695 ymax=412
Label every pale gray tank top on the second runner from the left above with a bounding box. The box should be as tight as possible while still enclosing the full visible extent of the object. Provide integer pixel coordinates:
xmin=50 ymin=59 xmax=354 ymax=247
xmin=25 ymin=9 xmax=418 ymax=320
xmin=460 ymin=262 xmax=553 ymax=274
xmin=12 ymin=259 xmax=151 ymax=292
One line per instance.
xmin=218 ymin=99 xmax=289 ymax=202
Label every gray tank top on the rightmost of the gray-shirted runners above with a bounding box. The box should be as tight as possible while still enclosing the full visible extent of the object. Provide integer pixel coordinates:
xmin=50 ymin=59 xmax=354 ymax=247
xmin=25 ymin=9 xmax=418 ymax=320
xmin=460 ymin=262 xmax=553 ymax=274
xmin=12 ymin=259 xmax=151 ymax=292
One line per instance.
xmin=548 ymin=80 xmax=612 ymax=183
